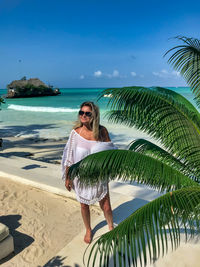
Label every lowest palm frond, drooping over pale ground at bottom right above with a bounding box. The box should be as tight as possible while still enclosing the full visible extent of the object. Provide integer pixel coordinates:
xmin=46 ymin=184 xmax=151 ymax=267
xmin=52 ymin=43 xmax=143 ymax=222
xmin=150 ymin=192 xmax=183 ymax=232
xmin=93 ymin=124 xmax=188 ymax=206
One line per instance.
xmin=87 ymin=186 xmax=200 ymax=267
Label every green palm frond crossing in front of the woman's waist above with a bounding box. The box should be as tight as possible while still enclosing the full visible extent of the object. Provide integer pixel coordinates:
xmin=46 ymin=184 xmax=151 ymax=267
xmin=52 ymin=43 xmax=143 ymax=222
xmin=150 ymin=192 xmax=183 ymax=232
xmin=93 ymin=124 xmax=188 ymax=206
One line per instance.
xmin=69 ymin=150 xmax=197 ymax=191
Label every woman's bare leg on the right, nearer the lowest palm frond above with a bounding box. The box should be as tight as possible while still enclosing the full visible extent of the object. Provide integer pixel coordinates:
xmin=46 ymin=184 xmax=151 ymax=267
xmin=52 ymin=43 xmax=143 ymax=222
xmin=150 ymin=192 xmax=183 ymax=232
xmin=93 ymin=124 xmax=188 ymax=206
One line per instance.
xmin=99 ymin=193 xmax=114 ymax=230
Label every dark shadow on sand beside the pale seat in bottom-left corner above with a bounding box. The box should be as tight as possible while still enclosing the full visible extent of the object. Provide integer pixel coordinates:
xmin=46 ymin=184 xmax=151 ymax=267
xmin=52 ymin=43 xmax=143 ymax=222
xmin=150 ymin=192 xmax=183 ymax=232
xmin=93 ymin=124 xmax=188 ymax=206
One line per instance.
xmin=0 ymin=214 xmax=34 ymax=265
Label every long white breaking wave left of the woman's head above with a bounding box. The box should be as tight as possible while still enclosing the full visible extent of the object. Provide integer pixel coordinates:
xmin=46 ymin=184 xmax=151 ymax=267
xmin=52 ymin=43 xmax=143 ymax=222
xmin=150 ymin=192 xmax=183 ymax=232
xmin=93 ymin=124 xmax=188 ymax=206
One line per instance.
xmin=8 ymin=104 xmax=79 ymax=113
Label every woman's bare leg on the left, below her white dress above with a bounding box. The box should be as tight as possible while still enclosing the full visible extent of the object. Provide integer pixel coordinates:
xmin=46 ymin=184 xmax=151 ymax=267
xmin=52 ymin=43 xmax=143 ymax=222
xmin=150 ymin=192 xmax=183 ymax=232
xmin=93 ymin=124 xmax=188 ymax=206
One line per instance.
xmin=81 ymin=203 xmax=92 ymax=243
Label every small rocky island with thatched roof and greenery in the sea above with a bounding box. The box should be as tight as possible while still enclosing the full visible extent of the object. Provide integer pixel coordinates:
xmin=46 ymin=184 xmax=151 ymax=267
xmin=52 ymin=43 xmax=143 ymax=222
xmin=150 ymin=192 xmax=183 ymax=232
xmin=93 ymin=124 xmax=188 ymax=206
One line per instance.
xmin=6 ymin=77 xmax=60 ymax=98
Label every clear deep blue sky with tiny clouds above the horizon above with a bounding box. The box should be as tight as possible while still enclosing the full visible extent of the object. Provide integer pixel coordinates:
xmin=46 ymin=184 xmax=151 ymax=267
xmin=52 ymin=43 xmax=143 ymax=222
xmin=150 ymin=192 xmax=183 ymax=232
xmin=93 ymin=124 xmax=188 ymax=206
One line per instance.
xmin=0 ymin=0 xmax=200 ymax=88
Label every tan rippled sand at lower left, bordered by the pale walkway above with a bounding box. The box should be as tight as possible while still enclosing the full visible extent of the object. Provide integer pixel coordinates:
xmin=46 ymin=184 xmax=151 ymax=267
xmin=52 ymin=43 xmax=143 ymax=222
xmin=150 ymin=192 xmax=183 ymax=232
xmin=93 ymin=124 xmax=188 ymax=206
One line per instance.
xmin=0 ymin=177 xmax=99 ymax=267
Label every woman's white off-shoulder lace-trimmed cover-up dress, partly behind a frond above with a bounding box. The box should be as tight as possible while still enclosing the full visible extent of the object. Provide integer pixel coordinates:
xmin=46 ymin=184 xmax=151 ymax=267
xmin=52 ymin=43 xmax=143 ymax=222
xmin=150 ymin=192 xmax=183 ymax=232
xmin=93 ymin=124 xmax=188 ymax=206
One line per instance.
xmin=62 ymin=130 xmax=117 ymax=205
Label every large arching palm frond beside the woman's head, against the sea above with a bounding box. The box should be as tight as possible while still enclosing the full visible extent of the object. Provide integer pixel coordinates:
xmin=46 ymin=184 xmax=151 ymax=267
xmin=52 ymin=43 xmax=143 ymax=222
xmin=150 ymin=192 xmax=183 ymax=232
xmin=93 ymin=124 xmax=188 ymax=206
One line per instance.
xmin=99 ymin=87 xmax=200 ymax=181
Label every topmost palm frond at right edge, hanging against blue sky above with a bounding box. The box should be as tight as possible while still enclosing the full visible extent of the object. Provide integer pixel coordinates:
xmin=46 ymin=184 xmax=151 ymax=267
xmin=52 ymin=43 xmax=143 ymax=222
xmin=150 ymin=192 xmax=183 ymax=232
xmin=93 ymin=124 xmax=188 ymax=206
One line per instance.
xmin=164 ymin=36 xmax=200 ymax=104
